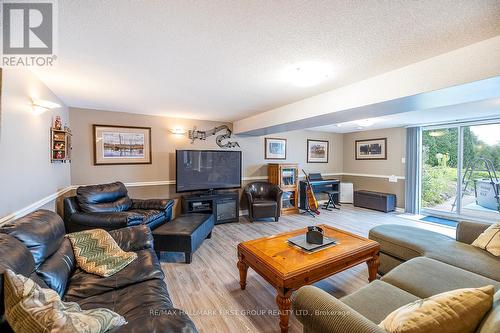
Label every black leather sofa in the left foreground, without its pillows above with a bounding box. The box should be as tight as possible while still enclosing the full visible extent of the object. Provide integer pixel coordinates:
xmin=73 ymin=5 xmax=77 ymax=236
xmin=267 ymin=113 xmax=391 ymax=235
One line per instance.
xmin=0 ymin=210 xmax=197 ymax=333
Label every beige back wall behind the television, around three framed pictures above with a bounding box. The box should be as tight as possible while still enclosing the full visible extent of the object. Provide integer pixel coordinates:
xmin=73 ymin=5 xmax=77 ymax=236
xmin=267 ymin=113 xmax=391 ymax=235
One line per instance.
xmin=70 ymin=108 xmax=343 ymax=204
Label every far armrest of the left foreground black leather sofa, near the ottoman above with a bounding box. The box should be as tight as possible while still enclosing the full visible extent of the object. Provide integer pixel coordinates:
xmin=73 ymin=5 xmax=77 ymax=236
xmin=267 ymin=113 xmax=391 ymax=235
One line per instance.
xmin=109 ymin=225 xmax=153 ymax=251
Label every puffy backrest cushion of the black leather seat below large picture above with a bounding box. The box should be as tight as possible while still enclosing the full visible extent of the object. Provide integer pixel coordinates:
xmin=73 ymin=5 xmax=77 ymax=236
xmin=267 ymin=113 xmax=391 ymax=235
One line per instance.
xmin=76 ymin=182 xmax=132 ymax=213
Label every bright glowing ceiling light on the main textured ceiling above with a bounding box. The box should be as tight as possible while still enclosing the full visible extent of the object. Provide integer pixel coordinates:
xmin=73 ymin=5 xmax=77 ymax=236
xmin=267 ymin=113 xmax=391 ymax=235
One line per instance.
xmin=284 ymin=61 xmax=332 ymax=87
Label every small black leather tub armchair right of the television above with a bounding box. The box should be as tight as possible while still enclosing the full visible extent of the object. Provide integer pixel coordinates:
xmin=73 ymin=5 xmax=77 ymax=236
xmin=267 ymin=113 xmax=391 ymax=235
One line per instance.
xmin=245 ymin=182 xmax=283 ymax=222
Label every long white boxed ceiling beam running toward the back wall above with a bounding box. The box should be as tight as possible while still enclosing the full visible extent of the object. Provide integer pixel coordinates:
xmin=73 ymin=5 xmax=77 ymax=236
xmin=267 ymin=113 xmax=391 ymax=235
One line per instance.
xmin=233 ymin=36 xmax=500 ymax=135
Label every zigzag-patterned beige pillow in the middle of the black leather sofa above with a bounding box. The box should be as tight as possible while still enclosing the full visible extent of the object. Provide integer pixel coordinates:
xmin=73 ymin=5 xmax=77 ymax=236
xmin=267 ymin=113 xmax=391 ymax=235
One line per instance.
xmin=66 ymin=229 xmax=137 ymax=277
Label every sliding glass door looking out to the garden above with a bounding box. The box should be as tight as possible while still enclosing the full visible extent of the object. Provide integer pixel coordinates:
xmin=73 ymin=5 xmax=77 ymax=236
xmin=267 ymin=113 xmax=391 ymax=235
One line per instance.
xmin=420 ymin=122 xmax=500 ymax=220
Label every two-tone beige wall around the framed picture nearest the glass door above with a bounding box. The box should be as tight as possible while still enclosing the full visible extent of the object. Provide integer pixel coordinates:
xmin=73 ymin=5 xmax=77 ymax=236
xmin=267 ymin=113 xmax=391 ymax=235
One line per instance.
xmin=342 ymin=127 xmax=406 ymax=208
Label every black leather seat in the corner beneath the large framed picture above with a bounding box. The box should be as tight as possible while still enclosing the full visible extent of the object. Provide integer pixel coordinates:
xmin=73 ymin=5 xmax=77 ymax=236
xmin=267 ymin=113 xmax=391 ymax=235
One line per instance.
xmin=64 ymin=182 xmax=174 ymax=232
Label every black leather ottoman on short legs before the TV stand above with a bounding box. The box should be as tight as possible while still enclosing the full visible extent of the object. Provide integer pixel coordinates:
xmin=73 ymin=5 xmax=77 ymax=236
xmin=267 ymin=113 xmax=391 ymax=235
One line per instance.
xmin=153 ymin=214 xmax=214 ymax=264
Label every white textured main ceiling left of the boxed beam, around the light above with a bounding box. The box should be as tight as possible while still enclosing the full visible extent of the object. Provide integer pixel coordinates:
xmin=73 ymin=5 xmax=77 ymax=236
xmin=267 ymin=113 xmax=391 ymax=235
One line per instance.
xmin=32 ymin=0 xmax=500 ymax=121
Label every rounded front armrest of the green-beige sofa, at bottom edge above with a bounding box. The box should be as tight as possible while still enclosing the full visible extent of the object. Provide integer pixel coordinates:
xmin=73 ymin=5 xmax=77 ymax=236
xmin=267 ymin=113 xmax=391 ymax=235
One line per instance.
xmin=293 ymin=286 xmax=386 ymax=333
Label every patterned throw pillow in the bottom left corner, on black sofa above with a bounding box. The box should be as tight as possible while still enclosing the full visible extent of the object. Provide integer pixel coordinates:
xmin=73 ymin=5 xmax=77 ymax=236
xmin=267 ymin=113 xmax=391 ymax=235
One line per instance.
xmin=4 ymin=270 xmax=127 ymax=333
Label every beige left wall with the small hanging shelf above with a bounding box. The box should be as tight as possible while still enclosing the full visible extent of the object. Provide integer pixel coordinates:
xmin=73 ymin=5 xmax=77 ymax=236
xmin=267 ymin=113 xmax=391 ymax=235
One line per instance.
xmin=0 ymin=68 xmax=70 ymax=219
